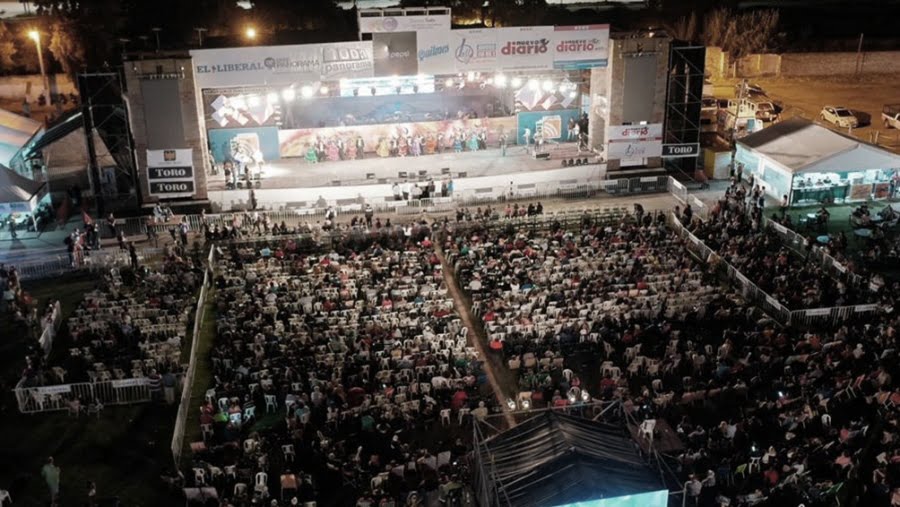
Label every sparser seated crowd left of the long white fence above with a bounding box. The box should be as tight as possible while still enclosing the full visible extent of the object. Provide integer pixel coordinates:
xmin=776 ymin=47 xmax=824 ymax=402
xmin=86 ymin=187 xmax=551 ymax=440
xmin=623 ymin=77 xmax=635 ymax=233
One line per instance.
xmin=18 ymin=253 xmax=203 ymax=412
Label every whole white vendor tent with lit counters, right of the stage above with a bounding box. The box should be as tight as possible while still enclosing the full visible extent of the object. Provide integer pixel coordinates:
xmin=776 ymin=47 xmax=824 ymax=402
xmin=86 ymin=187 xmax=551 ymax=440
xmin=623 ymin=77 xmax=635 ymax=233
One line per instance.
xmin=735 ymin=118 xmax=900 ymax=205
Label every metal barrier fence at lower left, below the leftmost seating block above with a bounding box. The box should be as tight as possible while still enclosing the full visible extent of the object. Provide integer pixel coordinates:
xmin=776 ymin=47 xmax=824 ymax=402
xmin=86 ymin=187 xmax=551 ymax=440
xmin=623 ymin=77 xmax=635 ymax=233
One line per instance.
xmin=13 ymin=377 xmax=152 ymax=414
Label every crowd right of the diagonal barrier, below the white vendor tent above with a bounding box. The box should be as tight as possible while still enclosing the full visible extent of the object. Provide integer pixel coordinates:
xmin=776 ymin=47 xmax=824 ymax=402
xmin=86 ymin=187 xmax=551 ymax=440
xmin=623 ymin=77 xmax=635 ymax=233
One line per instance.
xmin=677 ymin=184 xmax=877 ymax=310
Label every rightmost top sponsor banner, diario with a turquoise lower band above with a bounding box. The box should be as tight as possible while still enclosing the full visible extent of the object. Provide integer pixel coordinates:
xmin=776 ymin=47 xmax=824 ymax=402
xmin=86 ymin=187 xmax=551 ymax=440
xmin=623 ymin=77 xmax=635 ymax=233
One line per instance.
xmin=550 ymin=25 xmax=609 ymax=70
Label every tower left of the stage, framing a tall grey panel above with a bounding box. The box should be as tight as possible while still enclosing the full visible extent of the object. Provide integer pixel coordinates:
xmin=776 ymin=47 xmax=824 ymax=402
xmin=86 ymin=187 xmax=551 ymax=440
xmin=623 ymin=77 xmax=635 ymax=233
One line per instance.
xmin=125 ymin=57 xmax=210 ymax=203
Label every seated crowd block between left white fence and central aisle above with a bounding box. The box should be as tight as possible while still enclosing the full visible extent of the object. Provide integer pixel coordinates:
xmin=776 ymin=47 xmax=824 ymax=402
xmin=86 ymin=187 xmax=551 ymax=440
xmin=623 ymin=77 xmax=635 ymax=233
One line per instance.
xmin=187 ymin=228 xmax=486 ymax=505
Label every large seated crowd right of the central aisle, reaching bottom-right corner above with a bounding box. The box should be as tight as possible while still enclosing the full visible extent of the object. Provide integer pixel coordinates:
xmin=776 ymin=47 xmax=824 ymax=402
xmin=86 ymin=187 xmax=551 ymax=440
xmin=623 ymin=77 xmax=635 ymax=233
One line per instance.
xmin=445 ymin=207 xmax=900 ymax=506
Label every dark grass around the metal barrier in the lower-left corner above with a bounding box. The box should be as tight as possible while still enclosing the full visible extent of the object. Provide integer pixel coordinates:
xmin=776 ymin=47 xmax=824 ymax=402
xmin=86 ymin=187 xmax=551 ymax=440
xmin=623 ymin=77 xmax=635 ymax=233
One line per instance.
xmin=0 ymin=273 xmax=177 ymax=506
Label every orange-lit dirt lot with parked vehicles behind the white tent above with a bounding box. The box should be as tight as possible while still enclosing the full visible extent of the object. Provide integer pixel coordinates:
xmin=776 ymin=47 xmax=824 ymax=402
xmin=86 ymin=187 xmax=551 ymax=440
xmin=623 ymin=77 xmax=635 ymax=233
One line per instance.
xmin=714 ymin=74 xmax=900 ymax=152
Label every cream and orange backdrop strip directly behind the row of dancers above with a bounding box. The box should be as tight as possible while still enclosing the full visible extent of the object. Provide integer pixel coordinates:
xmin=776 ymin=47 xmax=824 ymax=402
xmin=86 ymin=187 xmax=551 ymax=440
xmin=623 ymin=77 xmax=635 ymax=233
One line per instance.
xmin=278 ymin=116 xmax=516 ymax=159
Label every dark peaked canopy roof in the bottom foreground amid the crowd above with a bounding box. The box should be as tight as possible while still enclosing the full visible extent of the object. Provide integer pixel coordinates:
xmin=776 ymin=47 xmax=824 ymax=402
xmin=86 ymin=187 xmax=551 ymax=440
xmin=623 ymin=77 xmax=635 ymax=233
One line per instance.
xmin=476 ymin=410 xmax=666 ymax=507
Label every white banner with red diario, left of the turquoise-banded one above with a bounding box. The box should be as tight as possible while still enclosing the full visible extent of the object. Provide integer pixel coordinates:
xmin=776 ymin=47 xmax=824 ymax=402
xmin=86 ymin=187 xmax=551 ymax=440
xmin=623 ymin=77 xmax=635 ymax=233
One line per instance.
xmin=491 ymin=26 xmax=554 ymax=70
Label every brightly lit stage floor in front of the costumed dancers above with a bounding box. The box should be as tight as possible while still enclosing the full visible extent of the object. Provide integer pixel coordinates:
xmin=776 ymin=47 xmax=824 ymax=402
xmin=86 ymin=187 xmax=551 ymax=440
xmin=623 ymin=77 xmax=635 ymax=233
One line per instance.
xmin=207 ymin=143 xmax=596 ymax=191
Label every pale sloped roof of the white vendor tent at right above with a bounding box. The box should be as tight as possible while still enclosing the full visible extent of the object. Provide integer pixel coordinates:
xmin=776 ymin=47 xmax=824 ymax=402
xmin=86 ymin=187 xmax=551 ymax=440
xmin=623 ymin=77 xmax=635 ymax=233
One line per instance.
xmin=737 ymin=118 xmax=900 ymax=174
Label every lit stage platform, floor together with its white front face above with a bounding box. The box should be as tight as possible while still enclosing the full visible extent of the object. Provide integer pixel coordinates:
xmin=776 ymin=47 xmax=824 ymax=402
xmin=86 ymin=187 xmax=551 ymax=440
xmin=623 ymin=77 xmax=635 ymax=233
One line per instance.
xmin=208 ymin=143 xmax=606 ymax=210
